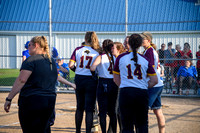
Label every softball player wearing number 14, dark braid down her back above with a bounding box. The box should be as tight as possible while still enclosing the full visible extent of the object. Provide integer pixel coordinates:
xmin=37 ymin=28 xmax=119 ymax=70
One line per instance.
xmin=113 ymin=34 xmax=158 ymax=133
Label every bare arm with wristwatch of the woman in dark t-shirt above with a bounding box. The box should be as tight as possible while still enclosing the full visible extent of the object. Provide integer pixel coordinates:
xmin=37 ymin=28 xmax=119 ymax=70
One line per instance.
xmin=4 ymin=70 xmax=32 ymax=112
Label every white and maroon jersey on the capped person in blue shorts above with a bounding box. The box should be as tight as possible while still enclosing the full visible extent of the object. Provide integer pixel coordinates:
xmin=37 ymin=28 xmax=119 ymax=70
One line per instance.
xmin=144 ymin=46 xmax=163 ymax=87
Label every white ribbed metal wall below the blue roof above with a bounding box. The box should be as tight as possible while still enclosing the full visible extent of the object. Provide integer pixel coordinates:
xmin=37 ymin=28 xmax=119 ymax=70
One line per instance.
xmin=0 ymin=33 xmax=200 ymax=68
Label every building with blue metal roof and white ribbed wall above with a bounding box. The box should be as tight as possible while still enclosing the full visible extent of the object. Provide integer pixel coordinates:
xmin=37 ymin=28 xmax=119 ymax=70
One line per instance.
xmin=0 ymin=0 xmax=200 ymax=68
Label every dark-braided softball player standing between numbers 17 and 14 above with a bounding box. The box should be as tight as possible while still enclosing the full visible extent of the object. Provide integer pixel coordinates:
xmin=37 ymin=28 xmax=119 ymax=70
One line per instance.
xmin=90 ymin=39 xmax=118 ymax=133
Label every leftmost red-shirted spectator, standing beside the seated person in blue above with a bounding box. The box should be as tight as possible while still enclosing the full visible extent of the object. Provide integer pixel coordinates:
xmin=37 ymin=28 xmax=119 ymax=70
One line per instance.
xmin=174 ymin=44 xmax=184 ymax=77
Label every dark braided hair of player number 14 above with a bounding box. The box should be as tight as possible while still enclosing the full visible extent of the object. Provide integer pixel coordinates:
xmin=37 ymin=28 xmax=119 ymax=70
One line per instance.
xmin=129 ymin=34 xmax=143 ymax=67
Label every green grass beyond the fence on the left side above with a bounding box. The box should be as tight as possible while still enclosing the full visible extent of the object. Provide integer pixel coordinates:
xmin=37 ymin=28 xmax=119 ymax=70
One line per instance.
xmin=0 ymin=69 xmax=75 ymax=86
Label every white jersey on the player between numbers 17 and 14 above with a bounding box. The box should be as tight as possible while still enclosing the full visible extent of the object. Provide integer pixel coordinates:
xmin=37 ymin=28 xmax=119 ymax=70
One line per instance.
xmin=97 ymin=54 xmax=115 ymax=78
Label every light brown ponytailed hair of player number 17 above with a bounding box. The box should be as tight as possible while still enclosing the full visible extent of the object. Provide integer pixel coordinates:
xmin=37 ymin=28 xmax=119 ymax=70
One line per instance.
xmin=85 ymin=31 xmax=100 ymax=51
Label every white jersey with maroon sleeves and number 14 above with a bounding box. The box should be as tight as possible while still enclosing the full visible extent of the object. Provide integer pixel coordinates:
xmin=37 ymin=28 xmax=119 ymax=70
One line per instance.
xmin=113 ymin=52 xmax=156 ymax=89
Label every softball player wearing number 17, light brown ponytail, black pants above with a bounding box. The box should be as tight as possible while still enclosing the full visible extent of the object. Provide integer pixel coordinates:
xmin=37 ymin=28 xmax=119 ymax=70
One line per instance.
xmin=69 ymin=32 xmax=100 ymax=133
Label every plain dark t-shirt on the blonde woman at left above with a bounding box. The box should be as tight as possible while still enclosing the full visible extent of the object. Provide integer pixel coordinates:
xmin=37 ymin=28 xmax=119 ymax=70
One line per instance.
xmin=20 ymin=54 xmax=58 ymax=97
